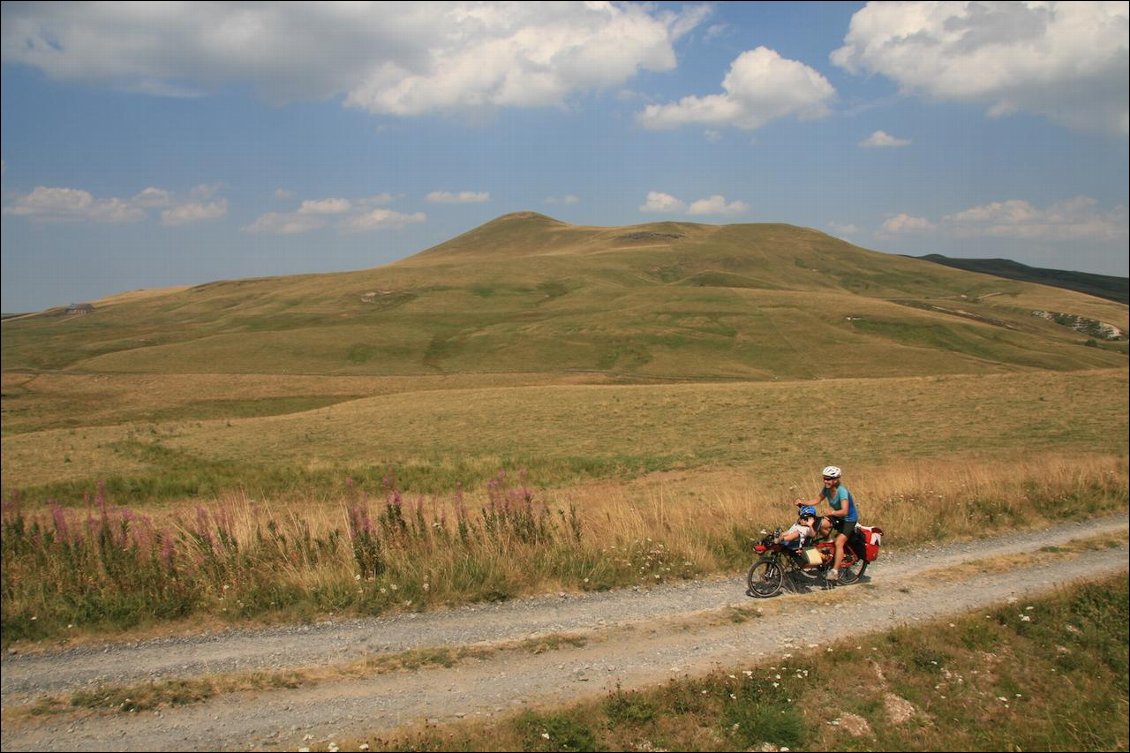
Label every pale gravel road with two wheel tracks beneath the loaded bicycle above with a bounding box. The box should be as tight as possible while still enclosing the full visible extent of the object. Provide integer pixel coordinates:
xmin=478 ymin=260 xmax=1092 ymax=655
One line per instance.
xmin=0 ymin=513 xmax=1130 ymax=751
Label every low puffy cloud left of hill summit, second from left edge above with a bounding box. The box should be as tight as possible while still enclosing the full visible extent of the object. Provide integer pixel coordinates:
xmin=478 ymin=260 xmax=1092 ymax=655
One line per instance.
xmin=243 ymin=193 xmax=427 ymax=235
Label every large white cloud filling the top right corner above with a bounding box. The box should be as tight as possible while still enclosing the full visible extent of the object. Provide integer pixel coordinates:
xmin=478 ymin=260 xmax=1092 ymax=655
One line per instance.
xmin=832 ymin=2 xmax=1130 ymax=136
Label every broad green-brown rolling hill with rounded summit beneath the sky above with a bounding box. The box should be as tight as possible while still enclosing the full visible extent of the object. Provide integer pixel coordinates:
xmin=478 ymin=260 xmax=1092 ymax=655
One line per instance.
xmin=2 ymin=213 xmax=1128 ymax=381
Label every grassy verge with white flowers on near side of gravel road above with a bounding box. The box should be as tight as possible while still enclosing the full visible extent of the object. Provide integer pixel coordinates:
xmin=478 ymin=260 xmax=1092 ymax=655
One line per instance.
xmin=327 ymin=574 xmax=1130 ymax=751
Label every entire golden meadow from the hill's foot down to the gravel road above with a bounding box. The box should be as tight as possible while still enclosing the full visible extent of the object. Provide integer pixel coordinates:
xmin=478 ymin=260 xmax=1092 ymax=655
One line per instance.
xmin=2 ymin=370 xmax=1128 ymax=644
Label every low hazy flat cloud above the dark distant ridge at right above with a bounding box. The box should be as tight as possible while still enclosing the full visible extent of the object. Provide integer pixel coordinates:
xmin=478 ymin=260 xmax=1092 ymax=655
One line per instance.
xmin=883 ymin=196 xmax=1128 ymax=241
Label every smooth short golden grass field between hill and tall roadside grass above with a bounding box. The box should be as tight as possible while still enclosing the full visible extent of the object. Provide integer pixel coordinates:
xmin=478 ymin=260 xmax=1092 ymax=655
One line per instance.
xmin=2 ymin=370 xmax=1128 ymax=492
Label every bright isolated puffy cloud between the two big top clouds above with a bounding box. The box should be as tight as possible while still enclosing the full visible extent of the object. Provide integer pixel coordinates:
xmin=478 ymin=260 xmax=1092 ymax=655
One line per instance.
xmin=637 ymin=47 xmax=836 ymax=130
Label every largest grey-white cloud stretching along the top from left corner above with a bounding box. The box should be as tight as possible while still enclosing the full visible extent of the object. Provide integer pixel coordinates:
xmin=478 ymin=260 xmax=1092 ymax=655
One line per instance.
xmin=0 ymin=2 xmax=710 ymax=115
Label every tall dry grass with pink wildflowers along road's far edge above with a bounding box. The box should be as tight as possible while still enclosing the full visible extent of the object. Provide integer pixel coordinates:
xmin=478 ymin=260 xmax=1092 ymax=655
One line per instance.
xmin=0 ymin=458 xmax=1128 ymax=644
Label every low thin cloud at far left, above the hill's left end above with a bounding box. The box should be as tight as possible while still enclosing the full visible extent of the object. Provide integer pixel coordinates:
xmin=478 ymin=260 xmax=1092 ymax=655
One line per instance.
xmin=3 ymin=185 xmax=227 ymax=225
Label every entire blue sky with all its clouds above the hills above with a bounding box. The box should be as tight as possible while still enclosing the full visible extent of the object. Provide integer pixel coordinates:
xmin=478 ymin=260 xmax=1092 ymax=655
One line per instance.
xmin=0 ymin=1 xmax=1130 ymax=312
